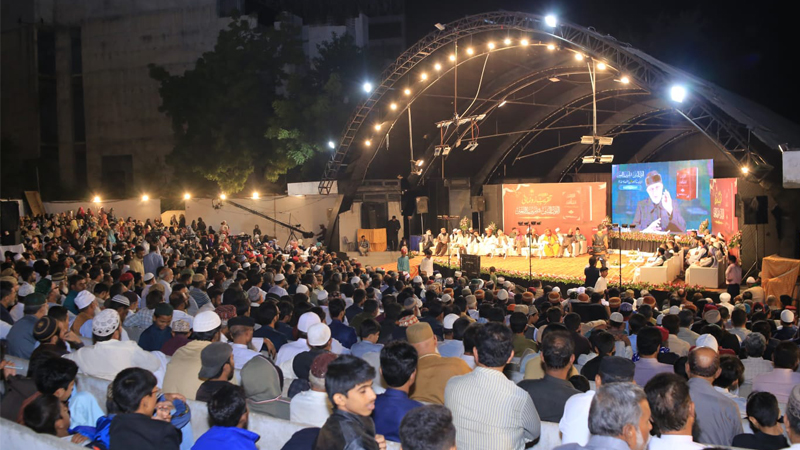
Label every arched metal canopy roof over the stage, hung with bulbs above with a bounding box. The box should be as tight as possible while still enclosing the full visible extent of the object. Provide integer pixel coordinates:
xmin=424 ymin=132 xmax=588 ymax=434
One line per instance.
xmin=319 ymin=12 xmax=800 ymax=195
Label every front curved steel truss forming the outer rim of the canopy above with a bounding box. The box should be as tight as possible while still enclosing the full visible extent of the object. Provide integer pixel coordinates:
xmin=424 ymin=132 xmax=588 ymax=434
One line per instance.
xmin=318 ymin=11 xmax=771 ymax=194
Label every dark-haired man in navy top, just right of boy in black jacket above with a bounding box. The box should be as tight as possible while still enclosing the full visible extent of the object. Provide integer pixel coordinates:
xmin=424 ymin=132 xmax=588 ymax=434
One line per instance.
xmin=372 ymin=341 xmax=422 ymax=442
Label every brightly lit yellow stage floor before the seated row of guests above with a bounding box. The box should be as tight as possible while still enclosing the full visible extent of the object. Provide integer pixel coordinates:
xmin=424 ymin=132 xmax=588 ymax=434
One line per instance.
xmin=380 ymin=250 xmax=652 ymax=284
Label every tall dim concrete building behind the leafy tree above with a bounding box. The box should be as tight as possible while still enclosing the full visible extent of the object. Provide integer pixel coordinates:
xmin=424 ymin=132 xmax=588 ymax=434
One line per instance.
xmin=0 ymin=0 xmax=405 ymax=200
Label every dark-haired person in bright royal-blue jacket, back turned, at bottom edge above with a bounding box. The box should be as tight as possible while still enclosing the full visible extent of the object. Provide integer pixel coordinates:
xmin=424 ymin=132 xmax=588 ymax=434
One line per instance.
xmin=192 ymin=384 xmax=261 ymax=450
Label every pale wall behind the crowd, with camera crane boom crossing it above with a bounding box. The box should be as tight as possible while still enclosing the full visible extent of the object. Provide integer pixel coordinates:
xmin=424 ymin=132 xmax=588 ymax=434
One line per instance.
xmin=186 ymin=195 xmax=337 ymax=244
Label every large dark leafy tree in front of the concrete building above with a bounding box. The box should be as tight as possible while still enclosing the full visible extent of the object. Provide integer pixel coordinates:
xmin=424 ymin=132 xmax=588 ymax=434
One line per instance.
xmin=150 ymin=18 xmax=370 ymax=193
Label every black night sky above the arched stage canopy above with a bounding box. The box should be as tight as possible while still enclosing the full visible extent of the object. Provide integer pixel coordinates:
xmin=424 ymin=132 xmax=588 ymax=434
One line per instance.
xmin=406 ymin=0 xmax=800 ymax=124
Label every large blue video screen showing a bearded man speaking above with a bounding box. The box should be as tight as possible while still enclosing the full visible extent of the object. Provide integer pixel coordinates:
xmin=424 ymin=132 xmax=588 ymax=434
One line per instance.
xmin=611 ymin=159 xmax=714 ymax=233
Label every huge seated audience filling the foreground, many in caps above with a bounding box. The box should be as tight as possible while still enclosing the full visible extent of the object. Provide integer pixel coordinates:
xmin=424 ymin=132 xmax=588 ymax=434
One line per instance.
xmin=0 ymin=209 xmax=800 ymax=450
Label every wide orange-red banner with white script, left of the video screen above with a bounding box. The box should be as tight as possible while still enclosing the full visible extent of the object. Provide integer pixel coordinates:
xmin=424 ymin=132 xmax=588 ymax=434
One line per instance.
xmin=503 ymin=183 xmax=606 ymax=236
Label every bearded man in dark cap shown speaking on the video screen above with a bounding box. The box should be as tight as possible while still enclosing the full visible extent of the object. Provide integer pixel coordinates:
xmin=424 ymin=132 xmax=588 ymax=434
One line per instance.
xmin=633 ymin=170 xmax=686 ymax=233
